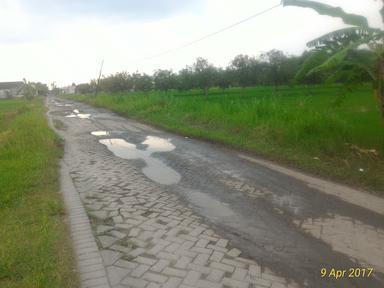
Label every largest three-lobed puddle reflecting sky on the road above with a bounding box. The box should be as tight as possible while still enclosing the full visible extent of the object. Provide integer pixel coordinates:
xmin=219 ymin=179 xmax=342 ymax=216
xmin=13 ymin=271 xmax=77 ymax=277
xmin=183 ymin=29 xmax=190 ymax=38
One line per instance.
xmin=99 ymin=136 xmax=181 ymax=185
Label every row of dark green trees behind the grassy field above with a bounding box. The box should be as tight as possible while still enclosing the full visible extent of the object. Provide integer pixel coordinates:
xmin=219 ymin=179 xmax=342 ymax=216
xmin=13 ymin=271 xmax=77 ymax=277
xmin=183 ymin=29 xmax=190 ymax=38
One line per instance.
xmin=76 ymin=50 xmax=369 ymax=95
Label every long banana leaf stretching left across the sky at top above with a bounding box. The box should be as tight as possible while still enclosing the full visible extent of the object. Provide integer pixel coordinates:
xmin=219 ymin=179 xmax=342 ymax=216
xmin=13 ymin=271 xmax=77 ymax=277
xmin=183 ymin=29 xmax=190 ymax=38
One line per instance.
xmin=283 ymin=0 xmax=368 ymax=27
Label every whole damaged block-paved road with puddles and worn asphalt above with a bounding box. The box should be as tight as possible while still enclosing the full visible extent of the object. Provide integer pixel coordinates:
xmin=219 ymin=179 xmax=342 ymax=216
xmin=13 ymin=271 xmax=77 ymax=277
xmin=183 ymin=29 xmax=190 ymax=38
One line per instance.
xmin=47 ymin=98 xmax=384 ymax=288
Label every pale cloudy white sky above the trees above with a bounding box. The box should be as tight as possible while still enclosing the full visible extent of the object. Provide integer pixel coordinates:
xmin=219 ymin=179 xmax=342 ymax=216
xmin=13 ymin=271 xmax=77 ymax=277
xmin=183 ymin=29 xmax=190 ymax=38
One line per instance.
xmin=0 ymin=0 xmax=383 ymax=86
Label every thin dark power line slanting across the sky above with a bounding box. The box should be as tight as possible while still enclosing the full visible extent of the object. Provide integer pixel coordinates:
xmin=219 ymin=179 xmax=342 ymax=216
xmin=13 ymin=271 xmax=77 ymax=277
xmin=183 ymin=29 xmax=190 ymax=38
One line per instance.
xmin=138 ymin=2 xmax=282 ymax=62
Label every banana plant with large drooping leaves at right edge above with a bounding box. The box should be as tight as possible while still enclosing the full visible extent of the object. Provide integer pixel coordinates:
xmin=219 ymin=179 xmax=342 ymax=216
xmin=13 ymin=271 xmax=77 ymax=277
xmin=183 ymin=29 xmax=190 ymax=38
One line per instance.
xmin=282 ymin=0 xmax=384 ymax=118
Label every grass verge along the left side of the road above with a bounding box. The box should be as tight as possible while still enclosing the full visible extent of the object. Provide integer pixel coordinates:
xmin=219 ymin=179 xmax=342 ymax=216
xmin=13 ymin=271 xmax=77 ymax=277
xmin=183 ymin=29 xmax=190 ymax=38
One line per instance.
xmin=0 ymin=99 xmax=78 ymax=288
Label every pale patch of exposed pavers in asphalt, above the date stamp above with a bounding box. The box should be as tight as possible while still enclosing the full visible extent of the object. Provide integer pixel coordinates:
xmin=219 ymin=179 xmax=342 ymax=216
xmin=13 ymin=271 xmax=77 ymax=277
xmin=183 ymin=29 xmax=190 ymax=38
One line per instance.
xmin=295 ymin=215 xmax=384 ymax=273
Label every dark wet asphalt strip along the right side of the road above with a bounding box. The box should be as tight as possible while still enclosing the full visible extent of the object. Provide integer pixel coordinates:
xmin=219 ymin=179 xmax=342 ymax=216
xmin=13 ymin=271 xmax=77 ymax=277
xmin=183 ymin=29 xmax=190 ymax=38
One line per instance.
xmin=49 ymin=99 xmax=384 ymax=288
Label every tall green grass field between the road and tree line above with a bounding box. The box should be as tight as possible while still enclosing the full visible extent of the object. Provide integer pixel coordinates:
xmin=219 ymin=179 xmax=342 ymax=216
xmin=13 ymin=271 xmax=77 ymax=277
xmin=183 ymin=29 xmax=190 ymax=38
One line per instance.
xmin=67 ymin=86 xmax=384 ymax=195
